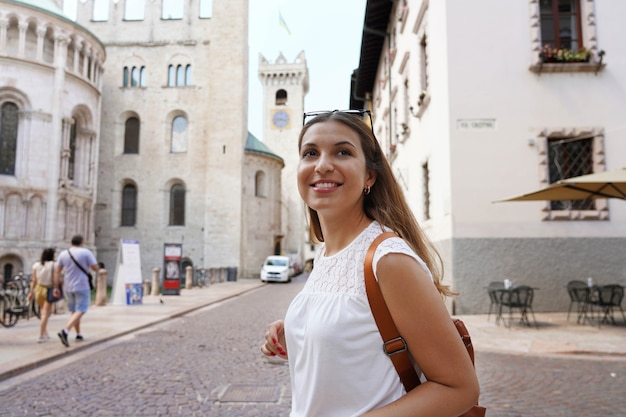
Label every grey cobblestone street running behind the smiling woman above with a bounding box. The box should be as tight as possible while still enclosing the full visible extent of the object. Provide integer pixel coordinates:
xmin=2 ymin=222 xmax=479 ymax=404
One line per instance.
xmin=0 ymin=278 xmax=626 ymax=417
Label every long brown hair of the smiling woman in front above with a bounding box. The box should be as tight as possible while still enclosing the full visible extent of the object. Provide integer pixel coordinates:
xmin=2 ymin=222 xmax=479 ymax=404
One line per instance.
xmin=298 ymin=111 xmax=455 ymax=296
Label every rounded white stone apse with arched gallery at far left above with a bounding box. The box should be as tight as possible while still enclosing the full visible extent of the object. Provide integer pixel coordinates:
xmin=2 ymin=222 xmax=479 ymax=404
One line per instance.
xmin=0 ymin=2 xmax=106 ymax=277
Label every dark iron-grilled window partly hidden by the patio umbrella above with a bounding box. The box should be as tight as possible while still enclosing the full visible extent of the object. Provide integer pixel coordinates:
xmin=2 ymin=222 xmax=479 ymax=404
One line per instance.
xmin=548 ymin=137 xmax=595 ymax=210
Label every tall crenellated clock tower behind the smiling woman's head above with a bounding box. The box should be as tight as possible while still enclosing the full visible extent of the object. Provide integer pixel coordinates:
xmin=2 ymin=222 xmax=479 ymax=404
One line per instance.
xmin=259 ymin=51 xmax=310 ymax=264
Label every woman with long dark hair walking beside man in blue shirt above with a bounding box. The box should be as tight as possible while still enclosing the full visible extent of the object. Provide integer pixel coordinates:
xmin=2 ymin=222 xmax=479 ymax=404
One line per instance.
xmin=28 ymin=248 xmax=54 ymax=343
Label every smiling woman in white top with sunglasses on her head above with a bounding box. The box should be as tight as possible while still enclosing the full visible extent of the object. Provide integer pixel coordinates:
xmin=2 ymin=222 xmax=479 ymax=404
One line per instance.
xmin=261 ymin=110 xmax=479 ymax=417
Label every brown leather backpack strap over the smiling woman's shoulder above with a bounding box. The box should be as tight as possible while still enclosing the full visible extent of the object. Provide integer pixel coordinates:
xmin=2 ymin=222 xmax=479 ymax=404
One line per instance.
xmin=364 ymin=232 xmax=420 ymax=392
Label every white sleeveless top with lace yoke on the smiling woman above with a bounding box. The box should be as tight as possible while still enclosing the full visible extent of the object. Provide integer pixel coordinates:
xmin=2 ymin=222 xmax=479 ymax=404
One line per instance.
xmin=285 ymin=222 xmax=430 ymax=417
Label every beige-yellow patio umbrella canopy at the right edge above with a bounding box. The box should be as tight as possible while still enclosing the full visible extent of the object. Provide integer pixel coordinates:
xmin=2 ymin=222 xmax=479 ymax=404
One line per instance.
xmin=497 ymin=167 xmax=626 ymax=202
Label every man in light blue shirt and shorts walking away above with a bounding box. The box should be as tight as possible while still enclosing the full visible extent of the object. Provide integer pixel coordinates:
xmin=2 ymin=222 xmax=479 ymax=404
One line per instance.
xmin=53 ymin=235 xmax=99 ymax=347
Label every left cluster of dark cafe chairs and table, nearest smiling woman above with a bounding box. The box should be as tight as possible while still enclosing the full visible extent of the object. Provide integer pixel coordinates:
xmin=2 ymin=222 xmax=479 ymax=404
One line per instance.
xmin=487 ymin=280 xmax=537 ymax=327
